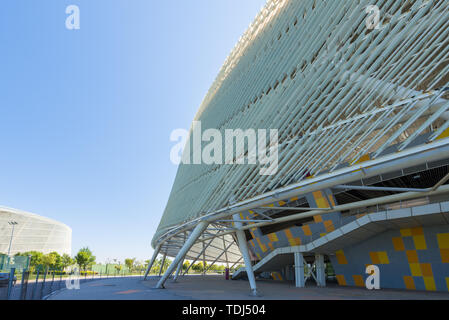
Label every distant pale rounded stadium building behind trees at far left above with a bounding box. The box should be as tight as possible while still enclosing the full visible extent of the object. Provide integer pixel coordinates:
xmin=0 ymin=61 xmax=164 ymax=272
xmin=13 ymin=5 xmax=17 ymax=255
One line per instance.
xmin=0 ymin=207 xmax=72 ymax=256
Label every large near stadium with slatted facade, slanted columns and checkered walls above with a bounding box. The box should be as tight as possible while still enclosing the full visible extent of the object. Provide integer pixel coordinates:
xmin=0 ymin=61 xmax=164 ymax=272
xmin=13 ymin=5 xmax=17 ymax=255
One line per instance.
xmin=149 ymin=0 xmax=449 ymax=292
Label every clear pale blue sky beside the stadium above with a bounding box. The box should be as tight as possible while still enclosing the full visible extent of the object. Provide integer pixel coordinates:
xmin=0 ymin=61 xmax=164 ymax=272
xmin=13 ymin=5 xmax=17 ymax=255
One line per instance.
xmin=0 ymin=0 xmax=265 ymax=261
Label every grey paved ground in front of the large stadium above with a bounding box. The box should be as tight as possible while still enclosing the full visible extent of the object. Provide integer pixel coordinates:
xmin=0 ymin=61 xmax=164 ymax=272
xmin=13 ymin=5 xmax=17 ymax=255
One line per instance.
xmin=49 ymin=276 xmax=449 ymax=301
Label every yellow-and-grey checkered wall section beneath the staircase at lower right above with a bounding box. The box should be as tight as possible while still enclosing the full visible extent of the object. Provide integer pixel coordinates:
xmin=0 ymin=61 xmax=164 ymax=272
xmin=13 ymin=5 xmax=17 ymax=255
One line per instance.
xmin=330 ymin=226 xmax=449 ymax=292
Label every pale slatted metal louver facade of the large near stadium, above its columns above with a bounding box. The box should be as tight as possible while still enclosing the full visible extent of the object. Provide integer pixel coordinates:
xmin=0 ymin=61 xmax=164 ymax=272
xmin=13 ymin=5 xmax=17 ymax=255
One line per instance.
xmin=153 ymin=0 xmax=449 ymax=262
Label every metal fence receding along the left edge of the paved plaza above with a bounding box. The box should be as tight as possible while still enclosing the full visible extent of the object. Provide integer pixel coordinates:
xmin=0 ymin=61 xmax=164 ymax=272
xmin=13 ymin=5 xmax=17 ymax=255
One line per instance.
xmin=0 ymin=268 xmax=143 ymax=300
